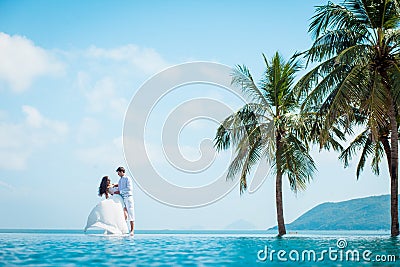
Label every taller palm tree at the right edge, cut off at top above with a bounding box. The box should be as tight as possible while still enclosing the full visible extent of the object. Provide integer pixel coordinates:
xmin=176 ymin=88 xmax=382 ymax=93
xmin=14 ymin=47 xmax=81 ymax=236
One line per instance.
xmin=297 ymin=0 xmax=400 ymax=236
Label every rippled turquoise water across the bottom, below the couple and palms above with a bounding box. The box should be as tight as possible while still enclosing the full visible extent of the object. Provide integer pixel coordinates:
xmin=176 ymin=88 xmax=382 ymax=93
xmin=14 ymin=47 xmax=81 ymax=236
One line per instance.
xmin=0 ymin=230 xmax=400 ymax=266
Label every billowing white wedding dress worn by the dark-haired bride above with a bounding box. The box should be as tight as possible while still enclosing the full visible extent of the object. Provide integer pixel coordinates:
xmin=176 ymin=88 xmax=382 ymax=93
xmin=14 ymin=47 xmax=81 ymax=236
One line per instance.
xmin=85 ymin=189 xmax=129 ymax=235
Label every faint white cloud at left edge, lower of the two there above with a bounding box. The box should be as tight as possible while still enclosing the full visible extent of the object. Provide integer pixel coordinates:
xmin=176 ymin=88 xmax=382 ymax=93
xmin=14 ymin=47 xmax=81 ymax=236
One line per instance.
xmin=0 ymin=106 xmax=68 ymax=170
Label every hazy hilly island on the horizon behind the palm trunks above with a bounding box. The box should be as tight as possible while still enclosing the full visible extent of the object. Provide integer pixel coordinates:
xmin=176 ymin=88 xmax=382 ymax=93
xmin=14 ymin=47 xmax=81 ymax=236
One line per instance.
xmin=268 ymin=195 xmax=400 ymax=231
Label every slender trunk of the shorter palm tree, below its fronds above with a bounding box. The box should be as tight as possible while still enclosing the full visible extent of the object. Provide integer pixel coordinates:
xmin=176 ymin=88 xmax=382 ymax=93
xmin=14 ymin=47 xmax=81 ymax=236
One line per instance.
xmin=275 ymin=133 xmax=286 ymax=236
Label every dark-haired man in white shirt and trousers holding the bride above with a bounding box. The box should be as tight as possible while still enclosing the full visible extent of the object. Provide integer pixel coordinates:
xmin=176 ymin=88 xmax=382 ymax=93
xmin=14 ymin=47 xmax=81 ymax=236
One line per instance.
xmin=115 ymin=167 xmax=135 ymax=235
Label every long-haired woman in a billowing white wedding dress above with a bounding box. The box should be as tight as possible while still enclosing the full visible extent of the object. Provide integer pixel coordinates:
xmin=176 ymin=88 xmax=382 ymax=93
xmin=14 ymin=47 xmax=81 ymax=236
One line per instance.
xmin=84 ymin=176 xmax=129 ymax=234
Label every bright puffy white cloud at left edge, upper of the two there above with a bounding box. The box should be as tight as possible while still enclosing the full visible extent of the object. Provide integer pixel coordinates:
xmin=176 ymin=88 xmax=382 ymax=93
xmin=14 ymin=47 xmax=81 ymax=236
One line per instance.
xmin=0 ymin=32 xmax=64 ymax=92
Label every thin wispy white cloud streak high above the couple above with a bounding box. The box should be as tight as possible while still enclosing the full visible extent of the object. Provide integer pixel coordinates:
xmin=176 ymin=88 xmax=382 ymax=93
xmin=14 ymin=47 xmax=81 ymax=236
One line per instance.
xmin=87 ymin=44 xmax=170 ymax=74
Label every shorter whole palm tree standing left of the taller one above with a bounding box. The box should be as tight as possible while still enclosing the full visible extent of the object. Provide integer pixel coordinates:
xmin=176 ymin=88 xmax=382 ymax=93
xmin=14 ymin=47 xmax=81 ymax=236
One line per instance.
xmin=215 ymin=53 xmax=315 ymax=236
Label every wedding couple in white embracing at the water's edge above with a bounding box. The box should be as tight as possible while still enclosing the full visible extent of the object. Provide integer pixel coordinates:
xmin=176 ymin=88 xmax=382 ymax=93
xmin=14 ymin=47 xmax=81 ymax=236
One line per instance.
xmin=85 ymin=167 xmax=135 ymax=236
